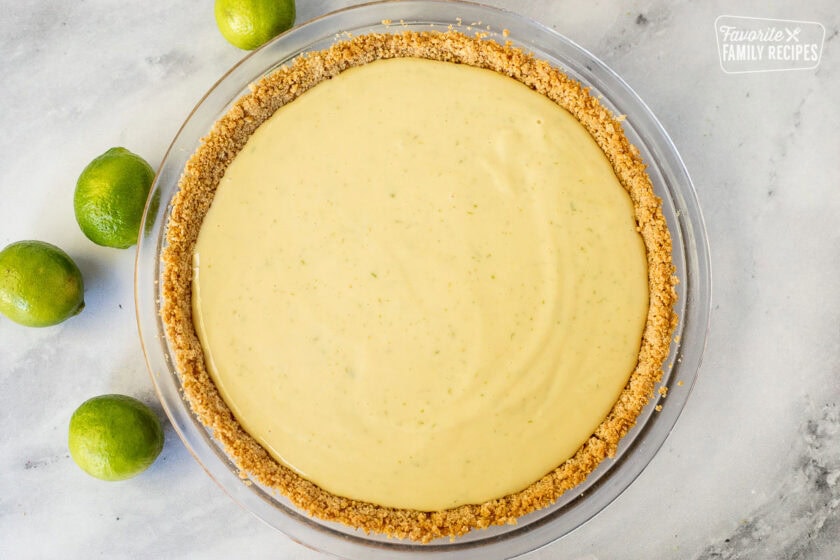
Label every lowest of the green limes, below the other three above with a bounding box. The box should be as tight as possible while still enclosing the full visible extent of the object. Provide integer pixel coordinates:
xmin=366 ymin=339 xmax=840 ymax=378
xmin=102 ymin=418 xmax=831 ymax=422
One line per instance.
xmin=67 ymin=395 xmax=163 ymax=480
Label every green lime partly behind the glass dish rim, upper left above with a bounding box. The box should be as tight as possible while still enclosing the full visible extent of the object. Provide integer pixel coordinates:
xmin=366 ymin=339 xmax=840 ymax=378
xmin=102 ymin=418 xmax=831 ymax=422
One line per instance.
xmin=73 ymin=148 xmax=155 ymax=249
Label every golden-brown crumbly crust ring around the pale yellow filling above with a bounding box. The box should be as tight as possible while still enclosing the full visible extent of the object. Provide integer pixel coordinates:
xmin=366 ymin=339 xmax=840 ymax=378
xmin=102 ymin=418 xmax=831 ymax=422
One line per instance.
xmin=161 ymin=30 xmax=677 ymax=542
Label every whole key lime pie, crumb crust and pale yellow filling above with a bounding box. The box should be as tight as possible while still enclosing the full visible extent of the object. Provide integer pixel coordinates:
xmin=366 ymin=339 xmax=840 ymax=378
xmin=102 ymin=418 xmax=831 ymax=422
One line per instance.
xmin=163 ymin=31 xmax=676 ymax=542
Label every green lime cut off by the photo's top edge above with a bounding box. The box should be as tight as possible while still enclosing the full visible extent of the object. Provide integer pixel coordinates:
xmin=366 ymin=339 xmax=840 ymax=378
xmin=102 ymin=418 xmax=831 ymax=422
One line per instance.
xmin=213 ymin=0 xmax=295 ymax=51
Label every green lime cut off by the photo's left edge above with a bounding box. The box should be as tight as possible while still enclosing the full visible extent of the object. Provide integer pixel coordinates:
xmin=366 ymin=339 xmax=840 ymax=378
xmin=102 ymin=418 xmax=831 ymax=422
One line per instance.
xmin=0 ymin=241 xmax=85 ymax=327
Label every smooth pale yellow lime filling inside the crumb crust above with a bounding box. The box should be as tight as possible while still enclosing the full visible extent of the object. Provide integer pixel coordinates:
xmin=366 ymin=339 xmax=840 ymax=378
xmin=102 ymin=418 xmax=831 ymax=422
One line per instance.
xmin=193 ymin=59 xmax=648 ymax=510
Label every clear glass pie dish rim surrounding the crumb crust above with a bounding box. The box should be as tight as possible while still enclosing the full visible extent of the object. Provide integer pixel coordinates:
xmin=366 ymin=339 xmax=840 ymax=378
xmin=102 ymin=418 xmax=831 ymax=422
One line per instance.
xmin=135 ymin=0 xmax=711 ymax=558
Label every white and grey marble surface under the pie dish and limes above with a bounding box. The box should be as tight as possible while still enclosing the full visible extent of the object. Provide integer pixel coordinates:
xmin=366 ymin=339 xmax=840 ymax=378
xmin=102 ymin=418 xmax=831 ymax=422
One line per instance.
xmin=0 ymin=0 xmax=840 ymax=560
